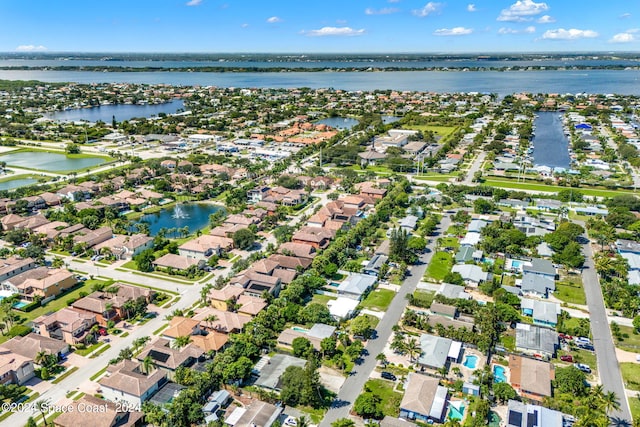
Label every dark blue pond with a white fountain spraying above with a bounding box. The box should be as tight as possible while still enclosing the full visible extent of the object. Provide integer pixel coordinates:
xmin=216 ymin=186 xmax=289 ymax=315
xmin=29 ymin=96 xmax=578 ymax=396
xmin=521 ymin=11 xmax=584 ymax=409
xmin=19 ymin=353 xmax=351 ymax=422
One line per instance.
xmin=137 ymin=203 xmax=223 ymax=237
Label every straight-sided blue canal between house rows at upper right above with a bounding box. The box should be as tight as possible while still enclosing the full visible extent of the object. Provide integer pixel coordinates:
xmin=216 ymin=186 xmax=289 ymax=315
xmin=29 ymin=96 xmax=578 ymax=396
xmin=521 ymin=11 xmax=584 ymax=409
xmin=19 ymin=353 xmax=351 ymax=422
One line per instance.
xmin=533 ymin=111 xmax=571 ymax=169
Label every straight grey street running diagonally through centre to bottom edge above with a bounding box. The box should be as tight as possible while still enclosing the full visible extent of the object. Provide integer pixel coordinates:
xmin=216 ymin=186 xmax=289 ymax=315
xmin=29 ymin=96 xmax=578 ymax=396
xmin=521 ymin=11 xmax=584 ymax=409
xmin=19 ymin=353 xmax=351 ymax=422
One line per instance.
xmin=319 ymin=216 xmax=451 ymax=427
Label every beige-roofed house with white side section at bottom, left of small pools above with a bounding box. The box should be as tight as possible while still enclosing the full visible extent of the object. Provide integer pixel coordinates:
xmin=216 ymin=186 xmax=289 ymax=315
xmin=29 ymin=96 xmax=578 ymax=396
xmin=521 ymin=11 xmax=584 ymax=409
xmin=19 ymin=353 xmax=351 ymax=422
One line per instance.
xmin=400 ymin=372 xmax=449 ymax=423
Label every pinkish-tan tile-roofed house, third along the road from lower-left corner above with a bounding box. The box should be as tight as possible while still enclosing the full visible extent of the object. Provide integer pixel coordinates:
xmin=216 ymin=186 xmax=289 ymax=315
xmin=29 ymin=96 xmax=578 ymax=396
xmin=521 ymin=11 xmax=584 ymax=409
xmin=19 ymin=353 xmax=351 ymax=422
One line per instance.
xmin=33 ymin=307 xmax=97 ymax=345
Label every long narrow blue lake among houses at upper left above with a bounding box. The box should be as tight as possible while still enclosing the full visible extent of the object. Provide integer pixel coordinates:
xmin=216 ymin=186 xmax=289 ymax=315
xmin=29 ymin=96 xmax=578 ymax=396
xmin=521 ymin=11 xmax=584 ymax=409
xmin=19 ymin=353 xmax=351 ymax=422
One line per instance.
xmin=45 ymin=99 xmax=184 ymax=123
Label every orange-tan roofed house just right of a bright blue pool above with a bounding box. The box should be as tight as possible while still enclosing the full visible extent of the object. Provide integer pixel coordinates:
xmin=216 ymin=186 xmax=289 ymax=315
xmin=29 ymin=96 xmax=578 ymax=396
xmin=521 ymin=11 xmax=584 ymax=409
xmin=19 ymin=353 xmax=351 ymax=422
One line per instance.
xmin=509 ymin=354 xmax=555 ymax=402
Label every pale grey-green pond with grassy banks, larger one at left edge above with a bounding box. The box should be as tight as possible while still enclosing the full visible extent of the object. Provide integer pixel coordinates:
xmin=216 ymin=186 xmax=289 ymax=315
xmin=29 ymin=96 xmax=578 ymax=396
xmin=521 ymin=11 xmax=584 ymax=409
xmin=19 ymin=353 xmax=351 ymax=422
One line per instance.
xmin=0 ymin=151 xmax=106 ymax=172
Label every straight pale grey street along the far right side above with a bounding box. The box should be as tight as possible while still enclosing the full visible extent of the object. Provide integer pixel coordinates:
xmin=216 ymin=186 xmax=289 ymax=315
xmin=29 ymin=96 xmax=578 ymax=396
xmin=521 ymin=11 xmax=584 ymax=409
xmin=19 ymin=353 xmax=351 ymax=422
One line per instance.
xmin=581 ymin=237 xmax=631 ymax=425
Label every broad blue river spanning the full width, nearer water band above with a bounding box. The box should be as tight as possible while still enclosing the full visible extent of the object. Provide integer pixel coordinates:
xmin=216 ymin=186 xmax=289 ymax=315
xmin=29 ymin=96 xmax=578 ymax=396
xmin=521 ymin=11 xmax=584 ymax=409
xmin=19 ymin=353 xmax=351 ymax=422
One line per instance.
xmin=0 ymin=70 xmax=640 ymax=96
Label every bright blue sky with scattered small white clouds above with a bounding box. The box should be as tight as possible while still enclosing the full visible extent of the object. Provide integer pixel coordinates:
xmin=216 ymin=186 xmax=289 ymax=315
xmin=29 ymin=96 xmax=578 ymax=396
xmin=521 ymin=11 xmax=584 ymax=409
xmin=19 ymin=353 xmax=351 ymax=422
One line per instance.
xmin=0 ymin=0 xmax=640 ymax=53
